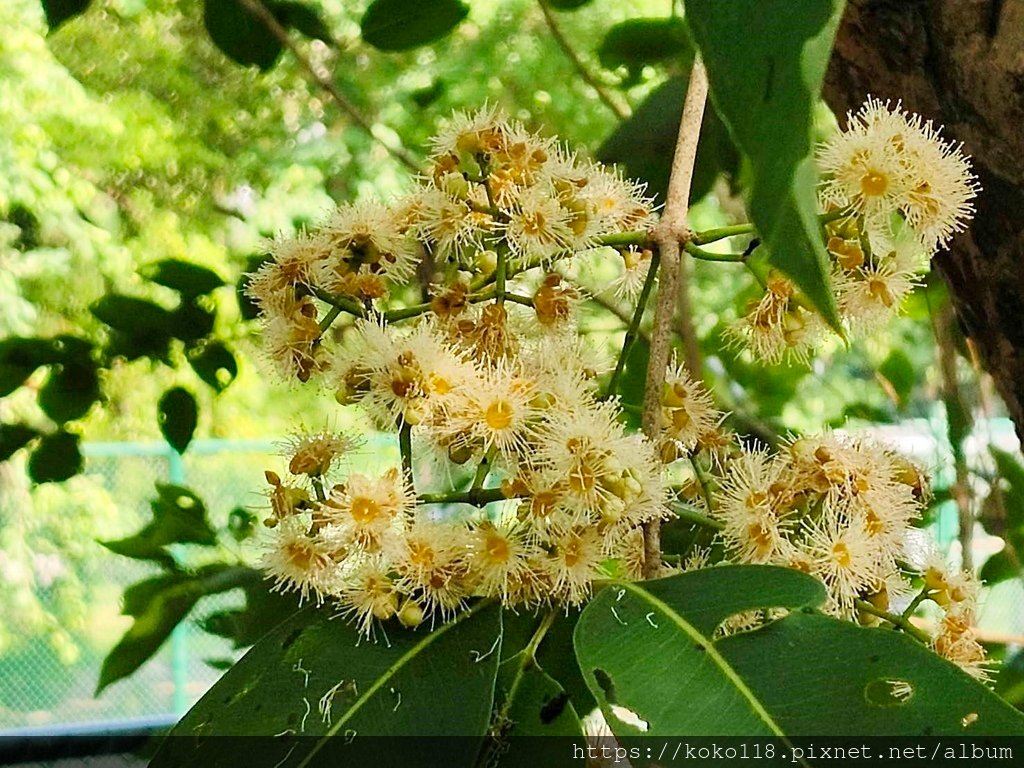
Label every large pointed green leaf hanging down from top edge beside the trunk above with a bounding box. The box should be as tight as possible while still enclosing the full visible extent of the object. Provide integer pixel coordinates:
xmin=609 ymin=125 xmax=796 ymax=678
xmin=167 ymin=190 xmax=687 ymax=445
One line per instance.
xmin=686 ymin=0 xmax=844 ymax=334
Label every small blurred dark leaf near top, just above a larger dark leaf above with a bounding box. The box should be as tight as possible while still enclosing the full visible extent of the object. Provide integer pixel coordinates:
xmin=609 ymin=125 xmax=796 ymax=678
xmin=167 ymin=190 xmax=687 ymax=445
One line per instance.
xmin=597 ymin=16 xmax=693 ymax=73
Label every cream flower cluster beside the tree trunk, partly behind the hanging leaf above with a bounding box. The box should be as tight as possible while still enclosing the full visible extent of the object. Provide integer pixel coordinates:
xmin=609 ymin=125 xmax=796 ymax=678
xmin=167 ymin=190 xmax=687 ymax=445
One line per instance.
xmin=731 ymin=99 xmax=979 ymax=364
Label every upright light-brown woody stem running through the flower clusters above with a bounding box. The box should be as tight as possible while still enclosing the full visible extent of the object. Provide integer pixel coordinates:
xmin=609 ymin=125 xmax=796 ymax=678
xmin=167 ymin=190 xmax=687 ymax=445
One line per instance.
xmin=643 ymin=55 xmax=708 ymax=579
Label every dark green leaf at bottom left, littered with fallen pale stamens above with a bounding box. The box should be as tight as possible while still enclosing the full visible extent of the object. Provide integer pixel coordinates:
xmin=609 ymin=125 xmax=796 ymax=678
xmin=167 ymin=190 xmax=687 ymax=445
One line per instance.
xmin=150 ymin=601 xmax=502 ymax=768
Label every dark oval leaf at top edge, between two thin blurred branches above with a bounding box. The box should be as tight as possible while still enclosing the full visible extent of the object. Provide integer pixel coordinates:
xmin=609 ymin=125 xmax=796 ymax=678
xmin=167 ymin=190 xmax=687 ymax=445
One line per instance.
xmin=359 ymin=0 xmax=469 ymax=51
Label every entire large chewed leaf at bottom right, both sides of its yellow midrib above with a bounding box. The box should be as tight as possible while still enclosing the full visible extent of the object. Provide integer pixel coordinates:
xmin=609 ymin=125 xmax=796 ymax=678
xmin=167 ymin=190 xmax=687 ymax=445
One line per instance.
xmin=575 ymin=565 xmax=1024 ymax=737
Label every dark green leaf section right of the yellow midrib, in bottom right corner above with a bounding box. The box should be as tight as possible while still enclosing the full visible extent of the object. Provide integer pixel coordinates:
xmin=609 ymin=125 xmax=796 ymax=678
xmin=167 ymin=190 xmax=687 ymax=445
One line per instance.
xmin=718 ymin=612 xmax=1024 ymax=738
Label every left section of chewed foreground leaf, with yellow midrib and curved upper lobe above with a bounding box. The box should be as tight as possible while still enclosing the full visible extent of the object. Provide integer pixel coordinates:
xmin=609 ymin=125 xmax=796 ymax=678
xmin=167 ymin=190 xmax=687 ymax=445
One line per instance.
xmin=575 ymin=566 xmax=824 ymax=736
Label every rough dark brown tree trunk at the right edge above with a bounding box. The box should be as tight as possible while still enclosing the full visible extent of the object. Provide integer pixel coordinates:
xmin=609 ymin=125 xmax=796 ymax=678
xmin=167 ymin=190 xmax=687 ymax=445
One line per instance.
xmin=825 ymin=0 xmax=1024 ymax=443
